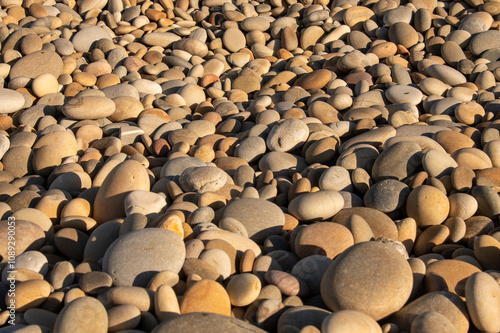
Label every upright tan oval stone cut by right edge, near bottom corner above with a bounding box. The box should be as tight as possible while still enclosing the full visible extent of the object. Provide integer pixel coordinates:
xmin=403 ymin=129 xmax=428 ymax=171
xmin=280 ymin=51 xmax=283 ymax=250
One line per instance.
xmin=465 ymin=272 xmax=500 ymax=332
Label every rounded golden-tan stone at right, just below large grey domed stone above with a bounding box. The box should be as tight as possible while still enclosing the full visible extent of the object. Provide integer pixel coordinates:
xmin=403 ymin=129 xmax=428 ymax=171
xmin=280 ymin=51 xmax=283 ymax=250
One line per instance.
xmin=406 ymin=185 xmax=450 ymax=227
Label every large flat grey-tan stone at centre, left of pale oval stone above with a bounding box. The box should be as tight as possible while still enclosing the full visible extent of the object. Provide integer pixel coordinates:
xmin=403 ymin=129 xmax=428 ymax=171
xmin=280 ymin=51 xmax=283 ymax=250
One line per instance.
xmin=221 ymin=198 xmax=285 ymax=244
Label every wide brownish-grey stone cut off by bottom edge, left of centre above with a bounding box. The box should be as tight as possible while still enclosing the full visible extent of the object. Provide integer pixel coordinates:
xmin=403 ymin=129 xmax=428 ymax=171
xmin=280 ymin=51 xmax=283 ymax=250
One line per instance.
xmin=152 ymin=312 xmax=266 ymax=333
